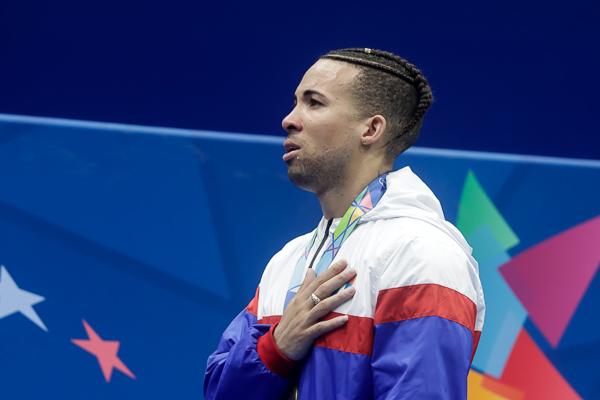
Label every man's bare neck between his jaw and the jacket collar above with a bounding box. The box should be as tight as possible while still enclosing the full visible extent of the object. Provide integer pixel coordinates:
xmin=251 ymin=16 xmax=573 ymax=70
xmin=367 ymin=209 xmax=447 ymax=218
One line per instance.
xmin=317 ymin=170 xmax=388 ymax=219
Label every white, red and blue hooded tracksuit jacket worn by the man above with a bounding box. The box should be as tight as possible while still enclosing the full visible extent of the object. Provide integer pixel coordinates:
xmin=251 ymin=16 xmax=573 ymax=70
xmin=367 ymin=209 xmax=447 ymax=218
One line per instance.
xmin=204 ymin=167 xmax=485 ymax=400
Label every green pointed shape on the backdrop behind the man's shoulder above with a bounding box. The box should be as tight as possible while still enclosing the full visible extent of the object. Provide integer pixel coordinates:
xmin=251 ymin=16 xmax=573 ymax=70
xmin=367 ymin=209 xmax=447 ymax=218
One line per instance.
xmin=456 ymin=170 xmax=519 ymax=250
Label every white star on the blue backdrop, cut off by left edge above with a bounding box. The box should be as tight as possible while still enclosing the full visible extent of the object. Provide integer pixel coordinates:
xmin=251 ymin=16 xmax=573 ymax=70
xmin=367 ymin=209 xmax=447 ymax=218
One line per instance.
xmin=0 ymin=265 xmax=48 ymax=332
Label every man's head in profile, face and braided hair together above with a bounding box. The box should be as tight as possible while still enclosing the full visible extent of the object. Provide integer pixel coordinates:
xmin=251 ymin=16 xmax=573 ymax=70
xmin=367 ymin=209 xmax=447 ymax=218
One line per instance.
xmin=282 ymin=49 xmax=431 ymax=194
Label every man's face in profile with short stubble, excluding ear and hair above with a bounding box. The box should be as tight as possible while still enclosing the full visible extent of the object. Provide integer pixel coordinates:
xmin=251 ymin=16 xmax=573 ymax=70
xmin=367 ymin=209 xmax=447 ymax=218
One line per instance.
xmin=282 ymin=60 xmax=361 ymax=195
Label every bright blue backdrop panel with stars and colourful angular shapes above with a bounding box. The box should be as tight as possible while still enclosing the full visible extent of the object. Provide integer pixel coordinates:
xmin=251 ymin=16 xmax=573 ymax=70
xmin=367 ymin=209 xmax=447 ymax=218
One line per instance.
xmin=0 ymin=115 xmax=600 ymax=400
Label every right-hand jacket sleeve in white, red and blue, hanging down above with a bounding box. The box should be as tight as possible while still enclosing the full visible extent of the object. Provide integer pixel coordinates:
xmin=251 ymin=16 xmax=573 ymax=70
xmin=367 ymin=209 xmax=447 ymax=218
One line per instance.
xmin=371 ymin=242 xmax=477 ymax=400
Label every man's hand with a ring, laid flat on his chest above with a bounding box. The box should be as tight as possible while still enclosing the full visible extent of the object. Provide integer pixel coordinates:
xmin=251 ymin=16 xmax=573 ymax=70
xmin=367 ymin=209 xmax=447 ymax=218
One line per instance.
xmin=273 ymin=260 xmax=356 ymax=361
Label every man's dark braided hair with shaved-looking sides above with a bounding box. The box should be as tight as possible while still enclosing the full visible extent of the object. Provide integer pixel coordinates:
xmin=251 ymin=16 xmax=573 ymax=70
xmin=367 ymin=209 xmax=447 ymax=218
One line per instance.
xmin=321 ymin=48 xmax=433 ymax=163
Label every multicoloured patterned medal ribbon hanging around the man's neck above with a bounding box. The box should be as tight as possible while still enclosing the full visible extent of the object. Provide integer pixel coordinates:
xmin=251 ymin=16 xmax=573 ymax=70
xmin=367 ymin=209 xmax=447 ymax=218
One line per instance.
xmin=284 ymin=174 xmax=388 ymax=309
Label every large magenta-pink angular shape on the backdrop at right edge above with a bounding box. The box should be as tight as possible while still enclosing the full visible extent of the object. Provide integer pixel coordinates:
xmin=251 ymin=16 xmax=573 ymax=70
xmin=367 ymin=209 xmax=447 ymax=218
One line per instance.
xmin=499 ymin=216 xmax=600 ymax=347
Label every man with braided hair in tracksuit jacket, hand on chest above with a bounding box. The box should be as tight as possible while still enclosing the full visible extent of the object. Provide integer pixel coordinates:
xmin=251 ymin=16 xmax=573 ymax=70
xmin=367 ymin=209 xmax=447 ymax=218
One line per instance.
xmin=204 ymin=49 xmax=485 ymax=399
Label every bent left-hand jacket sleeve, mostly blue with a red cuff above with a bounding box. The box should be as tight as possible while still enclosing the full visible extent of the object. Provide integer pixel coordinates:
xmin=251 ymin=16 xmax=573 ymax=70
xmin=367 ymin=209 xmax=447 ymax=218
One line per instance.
xmin=204 ymin=291 xmax=295 ymax=400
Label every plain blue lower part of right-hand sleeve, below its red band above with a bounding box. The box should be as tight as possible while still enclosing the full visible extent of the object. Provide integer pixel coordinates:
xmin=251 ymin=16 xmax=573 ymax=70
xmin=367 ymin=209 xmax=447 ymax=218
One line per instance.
xmin=372 ymin=316 xmax=473 ymax=400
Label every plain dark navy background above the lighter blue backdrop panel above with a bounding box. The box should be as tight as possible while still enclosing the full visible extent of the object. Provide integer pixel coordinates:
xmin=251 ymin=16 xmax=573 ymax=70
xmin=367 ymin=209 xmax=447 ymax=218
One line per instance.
xmin=0 ymin=0 xmax=600 ymax=159
